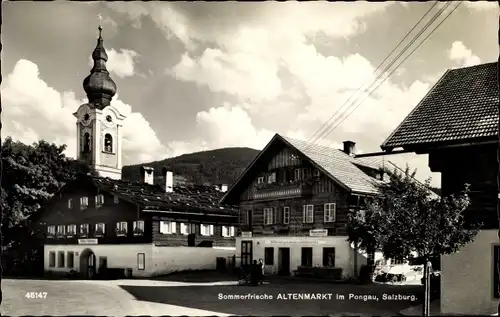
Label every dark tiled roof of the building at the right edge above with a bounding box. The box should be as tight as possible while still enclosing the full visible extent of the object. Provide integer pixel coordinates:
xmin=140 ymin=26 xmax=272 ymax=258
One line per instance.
xmin=381 ymin=63 xmax=500 ymax=150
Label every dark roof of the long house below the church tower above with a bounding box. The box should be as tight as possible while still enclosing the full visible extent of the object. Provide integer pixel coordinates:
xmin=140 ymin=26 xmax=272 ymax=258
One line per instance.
xmin=92 ymin=177 xmax=237 ymax=216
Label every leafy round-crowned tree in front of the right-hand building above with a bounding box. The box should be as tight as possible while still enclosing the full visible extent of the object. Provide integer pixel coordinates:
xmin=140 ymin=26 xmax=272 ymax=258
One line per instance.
xmin=348 ymin=166 xmax=481 ymax=314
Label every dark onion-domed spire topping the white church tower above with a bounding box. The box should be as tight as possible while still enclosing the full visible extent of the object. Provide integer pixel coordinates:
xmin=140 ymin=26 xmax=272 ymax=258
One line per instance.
xmin=83 ymin=25 xmax=116 ymax=109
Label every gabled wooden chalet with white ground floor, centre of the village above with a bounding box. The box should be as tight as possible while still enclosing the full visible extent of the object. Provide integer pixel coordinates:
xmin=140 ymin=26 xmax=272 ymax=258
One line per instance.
xmin=221 ymin=134 xmax=382 ymax=277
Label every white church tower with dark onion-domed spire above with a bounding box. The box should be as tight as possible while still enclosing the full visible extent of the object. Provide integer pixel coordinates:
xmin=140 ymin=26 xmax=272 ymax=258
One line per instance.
xmin=73 ymin=25 xmax=130 ymax=179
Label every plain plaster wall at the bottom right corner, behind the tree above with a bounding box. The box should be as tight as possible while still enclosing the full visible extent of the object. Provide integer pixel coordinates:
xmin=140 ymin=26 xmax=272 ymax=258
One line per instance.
xmin=441 ymin=230 xmax=499 ymax=315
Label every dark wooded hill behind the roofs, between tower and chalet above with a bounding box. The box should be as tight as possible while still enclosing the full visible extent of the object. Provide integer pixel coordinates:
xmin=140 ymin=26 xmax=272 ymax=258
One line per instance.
xmin=122 ymin=148 xmax=260 ymax=185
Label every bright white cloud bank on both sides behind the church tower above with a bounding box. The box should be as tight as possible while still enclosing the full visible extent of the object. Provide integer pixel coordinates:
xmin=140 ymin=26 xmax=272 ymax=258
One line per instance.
xmin=1 ymin=59 xmax=169 ymax=165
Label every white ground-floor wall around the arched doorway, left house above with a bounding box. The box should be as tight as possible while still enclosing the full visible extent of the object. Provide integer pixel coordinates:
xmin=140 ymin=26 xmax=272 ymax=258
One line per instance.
xmin=44 ymin=244 xmax=154 ymax=277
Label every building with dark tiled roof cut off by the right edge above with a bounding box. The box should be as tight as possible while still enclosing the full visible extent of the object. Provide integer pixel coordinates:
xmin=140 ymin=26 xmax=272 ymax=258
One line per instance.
xmin=382 ymin=63 xmax=500 ymax=315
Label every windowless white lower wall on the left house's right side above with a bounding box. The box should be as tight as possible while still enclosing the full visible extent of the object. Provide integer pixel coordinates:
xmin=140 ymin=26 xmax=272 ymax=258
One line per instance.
xmin=152 ymin=246 xmax=235 ymax=275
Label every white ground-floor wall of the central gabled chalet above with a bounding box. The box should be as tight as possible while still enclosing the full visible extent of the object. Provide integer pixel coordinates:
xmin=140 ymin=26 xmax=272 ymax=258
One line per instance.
xmin=236 ymin=236 xmax=356 ymax=277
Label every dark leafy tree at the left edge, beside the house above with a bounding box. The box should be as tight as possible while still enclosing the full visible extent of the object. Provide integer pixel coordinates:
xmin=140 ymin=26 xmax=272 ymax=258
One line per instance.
xmin=0 ymin=137 xmax=95 ymax=246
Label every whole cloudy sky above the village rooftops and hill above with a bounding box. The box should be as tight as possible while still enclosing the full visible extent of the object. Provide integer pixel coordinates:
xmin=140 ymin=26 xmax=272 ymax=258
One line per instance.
xmin=1 ymin=1 xmax=498 ymax=185
